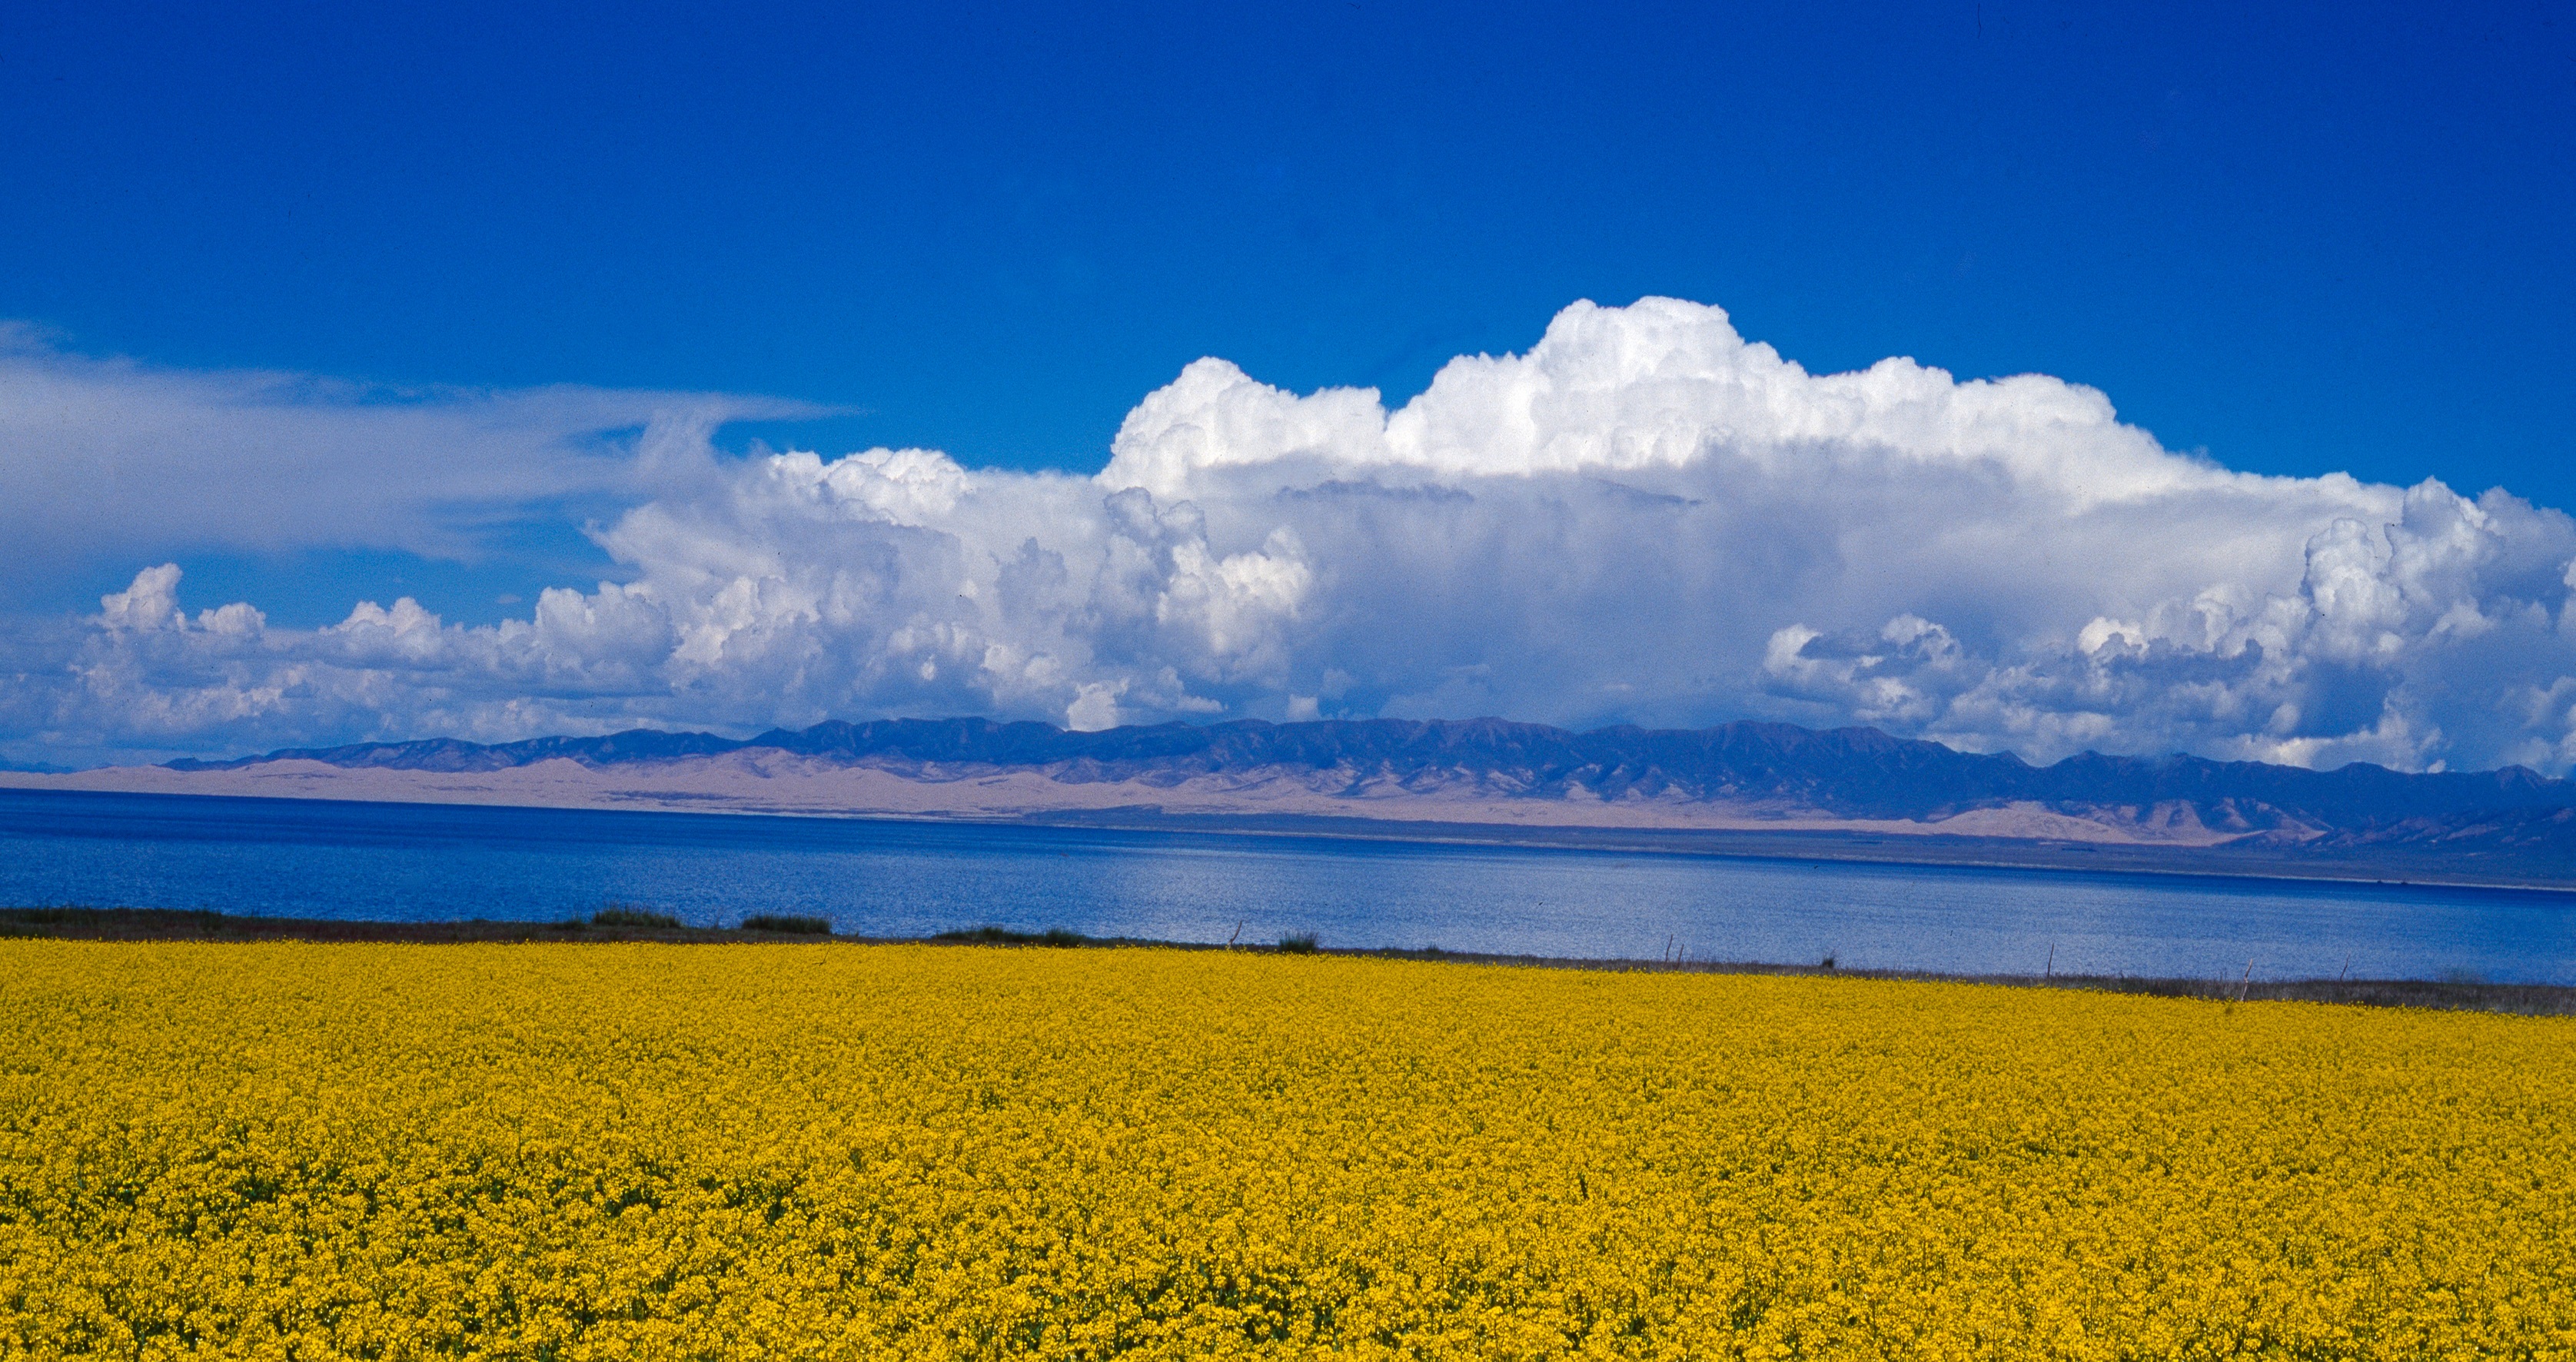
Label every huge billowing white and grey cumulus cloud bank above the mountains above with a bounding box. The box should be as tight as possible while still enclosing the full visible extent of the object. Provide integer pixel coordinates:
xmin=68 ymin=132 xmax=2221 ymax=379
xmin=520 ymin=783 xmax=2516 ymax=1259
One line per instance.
xmin=0 ymin=299 xmax=2576 ymax=772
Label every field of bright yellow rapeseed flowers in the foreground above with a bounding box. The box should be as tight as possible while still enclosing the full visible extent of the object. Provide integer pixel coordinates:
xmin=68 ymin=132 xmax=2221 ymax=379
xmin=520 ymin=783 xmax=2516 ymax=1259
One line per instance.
xmin=0 ymin=942 xmax=2576 ymax=1360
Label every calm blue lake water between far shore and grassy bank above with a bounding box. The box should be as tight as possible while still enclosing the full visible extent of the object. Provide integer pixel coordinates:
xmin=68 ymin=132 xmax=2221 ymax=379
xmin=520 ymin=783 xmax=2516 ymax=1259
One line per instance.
xmin=0 ymin=790 xmax=2576 ymax=984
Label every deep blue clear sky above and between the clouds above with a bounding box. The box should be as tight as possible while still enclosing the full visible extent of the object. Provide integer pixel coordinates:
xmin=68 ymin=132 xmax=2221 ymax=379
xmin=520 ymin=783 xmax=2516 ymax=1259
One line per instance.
xmin=0 ymin=0 xmax=2576 ymax=772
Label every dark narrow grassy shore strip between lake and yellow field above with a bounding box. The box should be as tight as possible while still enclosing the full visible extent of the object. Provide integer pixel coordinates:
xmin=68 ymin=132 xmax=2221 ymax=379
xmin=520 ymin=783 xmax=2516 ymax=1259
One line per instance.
xmin=0 ymin=904 xmax=2576 ymax=1017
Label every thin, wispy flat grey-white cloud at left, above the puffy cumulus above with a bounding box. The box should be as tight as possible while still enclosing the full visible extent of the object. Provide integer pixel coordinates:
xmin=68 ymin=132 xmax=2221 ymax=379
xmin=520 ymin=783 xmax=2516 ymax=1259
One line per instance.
xmin=0 ymin=324 xmax=814 ymax=587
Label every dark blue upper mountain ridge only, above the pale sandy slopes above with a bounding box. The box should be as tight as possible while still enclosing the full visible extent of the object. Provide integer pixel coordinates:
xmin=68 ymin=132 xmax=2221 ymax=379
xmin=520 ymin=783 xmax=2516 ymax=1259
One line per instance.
xmin=168 ymin=719 xmax=2576 ymax=847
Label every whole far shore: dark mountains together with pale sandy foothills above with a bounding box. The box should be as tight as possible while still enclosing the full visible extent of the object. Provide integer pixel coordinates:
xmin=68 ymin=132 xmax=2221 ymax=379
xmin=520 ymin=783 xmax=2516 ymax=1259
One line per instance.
xmin=0 ymin=719 xmax=2576 ymax=885
